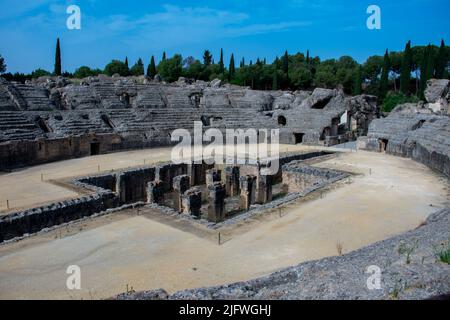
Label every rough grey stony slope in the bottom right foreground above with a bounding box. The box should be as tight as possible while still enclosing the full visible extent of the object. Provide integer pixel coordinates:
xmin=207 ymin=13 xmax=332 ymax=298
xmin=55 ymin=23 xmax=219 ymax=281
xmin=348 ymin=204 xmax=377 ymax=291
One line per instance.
xmin=117 ymin=207 xmax=450 ymax=300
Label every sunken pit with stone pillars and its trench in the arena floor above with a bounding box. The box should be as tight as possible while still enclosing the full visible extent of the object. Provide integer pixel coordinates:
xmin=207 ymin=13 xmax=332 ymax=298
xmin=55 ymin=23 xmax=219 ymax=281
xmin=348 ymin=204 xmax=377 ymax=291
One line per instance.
xmin=0 ymin=152 xmax=346 ymax=242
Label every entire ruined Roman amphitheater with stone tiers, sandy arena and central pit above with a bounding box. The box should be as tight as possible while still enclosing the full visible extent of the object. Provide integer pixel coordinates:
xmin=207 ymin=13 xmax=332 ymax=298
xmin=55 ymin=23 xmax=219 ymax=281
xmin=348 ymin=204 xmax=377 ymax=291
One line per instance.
xmin=0 ymin=75 xmax=450 ymax=299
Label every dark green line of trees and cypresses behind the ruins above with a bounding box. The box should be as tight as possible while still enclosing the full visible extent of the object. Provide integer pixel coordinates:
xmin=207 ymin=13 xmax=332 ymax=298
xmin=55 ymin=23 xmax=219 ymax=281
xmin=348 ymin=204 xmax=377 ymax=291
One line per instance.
xmin=0 ymin=39 xmax=450 ymax=111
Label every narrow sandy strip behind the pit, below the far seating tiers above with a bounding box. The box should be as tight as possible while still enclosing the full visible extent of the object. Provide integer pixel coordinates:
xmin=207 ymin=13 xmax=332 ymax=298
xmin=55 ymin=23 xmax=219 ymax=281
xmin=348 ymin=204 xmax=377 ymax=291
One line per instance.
xmin=0 ymin=145 xmax=312 ymax=215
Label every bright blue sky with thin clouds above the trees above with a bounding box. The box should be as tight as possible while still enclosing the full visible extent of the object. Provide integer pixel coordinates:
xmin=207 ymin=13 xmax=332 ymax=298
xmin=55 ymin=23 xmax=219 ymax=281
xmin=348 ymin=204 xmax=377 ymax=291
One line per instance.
xmin=0 ymin=0 xmax=450 ymax=72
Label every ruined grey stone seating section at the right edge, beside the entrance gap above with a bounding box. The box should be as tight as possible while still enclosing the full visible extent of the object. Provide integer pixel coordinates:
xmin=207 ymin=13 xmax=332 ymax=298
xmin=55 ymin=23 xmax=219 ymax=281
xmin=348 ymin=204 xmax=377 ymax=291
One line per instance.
xmin=358 ymin=79 xmax=450 ymax=176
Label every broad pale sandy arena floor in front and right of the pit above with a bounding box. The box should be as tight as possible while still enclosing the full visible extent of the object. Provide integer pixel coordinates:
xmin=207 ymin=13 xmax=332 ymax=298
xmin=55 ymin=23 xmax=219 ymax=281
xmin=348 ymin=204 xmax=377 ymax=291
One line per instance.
xmin=0 ymin=151 xmax=450 ymax=299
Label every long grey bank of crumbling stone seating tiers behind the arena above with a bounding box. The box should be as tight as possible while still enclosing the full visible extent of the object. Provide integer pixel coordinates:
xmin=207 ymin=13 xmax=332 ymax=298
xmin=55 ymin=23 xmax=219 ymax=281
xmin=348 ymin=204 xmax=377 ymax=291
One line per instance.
xmin=0 ymin=76 xmax=379 ymax=170
